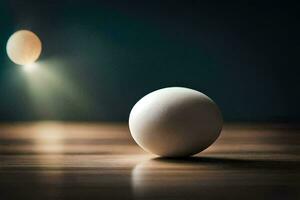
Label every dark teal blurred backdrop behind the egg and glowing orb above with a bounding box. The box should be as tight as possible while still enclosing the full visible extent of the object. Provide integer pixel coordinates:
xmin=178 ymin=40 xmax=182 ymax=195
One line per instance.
xmin=0 ymin=0 xmax=300 ymax=121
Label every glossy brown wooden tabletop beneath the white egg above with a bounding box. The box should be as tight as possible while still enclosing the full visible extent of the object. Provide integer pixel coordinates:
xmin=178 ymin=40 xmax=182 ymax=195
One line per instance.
xmin=0 ymin=122 xmax=300 ymax=200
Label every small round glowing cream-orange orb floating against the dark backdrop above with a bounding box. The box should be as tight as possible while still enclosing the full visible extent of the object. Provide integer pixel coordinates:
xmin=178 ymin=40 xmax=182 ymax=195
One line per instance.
xmin=6 ymin=30 xmax=42 ymax=65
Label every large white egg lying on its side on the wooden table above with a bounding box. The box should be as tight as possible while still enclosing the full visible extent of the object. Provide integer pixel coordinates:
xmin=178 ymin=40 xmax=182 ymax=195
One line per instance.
xmin=129 ymin=87 xmax=223 ymax=157
